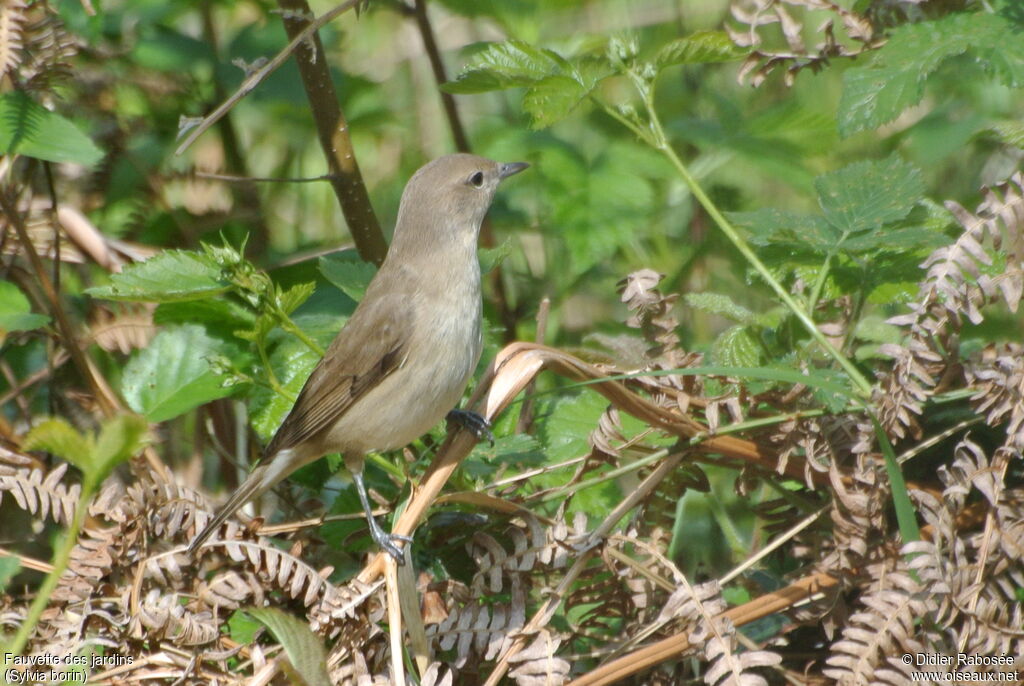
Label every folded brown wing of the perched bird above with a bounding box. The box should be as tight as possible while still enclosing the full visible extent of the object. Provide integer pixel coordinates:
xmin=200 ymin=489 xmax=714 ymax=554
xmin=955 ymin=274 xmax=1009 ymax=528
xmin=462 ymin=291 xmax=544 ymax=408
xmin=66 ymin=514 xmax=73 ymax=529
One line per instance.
xmin=260 ymin=295 xmax=413 ymax=463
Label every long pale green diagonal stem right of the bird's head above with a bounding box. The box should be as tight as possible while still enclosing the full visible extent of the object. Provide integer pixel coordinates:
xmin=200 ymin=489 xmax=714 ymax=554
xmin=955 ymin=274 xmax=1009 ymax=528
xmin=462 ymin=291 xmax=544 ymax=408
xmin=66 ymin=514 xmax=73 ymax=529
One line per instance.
xmin=604 ymin=79 xmax=871 ymax=397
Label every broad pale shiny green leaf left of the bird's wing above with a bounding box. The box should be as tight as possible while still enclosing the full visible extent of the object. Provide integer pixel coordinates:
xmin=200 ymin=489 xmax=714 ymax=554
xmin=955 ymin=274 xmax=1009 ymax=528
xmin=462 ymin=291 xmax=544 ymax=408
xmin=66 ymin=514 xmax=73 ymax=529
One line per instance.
xmin=121 ymin=325 xmax=233 ymax=422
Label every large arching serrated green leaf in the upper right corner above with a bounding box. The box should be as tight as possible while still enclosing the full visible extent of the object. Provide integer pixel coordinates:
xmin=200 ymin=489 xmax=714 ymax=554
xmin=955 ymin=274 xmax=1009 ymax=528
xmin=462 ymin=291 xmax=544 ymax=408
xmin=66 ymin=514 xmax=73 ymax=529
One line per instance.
xmin=839 ymin=12 xmax=1024 ymax=136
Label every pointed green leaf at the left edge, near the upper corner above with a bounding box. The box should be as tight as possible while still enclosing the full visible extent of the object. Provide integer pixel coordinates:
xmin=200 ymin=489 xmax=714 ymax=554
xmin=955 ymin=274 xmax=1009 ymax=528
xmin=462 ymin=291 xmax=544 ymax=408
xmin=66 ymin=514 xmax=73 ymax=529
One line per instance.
xmin=0 ymin=91 xmax=103 ymax=167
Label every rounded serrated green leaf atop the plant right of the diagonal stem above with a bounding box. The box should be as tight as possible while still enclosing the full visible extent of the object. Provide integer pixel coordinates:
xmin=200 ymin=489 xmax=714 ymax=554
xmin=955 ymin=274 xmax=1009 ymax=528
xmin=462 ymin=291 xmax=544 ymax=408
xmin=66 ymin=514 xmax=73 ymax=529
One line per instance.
xmin=814 ymin=156 xmax=925 ymax=239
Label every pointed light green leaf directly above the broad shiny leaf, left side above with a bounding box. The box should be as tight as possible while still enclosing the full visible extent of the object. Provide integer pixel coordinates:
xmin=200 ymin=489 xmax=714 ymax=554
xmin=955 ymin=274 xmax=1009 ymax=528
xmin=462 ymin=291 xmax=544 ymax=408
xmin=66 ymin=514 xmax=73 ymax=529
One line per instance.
xmin=86 ymin=250 xmax=230 ymax=302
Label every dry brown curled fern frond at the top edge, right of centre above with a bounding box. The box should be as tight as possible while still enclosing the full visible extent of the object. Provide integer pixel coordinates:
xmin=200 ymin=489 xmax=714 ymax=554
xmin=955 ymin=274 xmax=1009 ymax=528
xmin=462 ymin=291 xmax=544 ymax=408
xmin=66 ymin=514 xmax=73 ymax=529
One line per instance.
xmin=727 ymin=0 xmax=884 ymax=87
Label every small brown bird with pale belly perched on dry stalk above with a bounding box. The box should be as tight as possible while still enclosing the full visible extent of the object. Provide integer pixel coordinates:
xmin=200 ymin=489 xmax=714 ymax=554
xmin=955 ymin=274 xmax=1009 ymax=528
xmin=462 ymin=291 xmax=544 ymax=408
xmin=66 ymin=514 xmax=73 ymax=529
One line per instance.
xmin=188 ymin=155 xmax=528 ymax=563
